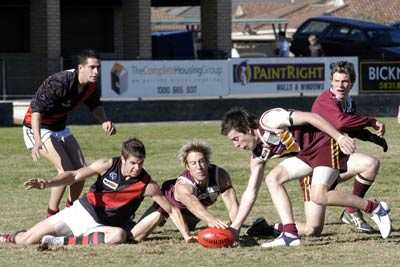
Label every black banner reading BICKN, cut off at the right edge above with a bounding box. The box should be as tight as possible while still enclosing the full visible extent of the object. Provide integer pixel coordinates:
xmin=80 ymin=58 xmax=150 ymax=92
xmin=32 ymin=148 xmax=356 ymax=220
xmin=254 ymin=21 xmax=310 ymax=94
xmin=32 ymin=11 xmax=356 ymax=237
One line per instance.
xmin=360 ymin=62 xmax=400 ymax=92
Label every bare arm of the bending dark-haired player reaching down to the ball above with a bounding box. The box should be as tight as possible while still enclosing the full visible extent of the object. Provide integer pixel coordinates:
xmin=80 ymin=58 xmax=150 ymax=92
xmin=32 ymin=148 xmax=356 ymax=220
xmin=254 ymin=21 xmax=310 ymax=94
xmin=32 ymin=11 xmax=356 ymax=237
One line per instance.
xmin=231 ymin=157 xmax=265 ymax=231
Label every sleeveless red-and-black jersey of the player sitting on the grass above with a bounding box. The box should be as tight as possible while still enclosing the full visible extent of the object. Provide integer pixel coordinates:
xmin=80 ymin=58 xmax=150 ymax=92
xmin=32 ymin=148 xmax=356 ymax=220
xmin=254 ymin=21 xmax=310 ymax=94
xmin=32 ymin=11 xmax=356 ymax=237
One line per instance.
xmin=79 ymin=157 xmax=151 ymax=227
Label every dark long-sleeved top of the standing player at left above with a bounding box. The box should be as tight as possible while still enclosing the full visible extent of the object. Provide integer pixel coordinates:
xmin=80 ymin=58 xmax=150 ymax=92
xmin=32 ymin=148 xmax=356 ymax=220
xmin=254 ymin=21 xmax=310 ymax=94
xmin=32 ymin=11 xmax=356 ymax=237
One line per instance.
xmin=23 ymin=70 xmax=101 ymax=131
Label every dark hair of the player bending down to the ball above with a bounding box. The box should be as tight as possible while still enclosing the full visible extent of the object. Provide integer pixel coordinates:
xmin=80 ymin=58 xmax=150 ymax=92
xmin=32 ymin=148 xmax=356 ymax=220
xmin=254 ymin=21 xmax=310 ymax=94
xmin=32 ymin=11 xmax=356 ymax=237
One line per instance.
xmin=221 ymin=107 xmax=258 ymax=136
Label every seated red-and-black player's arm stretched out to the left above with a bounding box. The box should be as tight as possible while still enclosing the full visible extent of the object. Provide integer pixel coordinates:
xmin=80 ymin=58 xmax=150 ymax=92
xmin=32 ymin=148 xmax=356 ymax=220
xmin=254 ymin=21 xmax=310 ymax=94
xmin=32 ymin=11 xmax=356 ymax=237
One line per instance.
xmin=24 ymin=160 xmax=112 ymax=189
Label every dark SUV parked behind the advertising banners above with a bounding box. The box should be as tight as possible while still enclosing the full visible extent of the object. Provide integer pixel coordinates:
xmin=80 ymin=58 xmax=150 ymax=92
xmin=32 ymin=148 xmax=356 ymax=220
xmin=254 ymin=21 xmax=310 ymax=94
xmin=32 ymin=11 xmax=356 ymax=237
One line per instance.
xmin=290 ymin=16 xmax=400 ymax=60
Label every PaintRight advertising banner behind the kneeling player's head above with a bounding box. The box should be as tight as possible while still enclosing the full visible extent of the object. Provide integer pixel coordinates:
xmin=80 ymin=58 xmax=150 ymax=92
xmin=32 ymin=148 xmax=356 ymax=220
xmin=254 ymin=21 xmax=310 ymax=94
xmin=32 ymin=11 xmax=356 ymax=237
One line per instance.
xmin=230 ymin=57 xmax=359 ymax=96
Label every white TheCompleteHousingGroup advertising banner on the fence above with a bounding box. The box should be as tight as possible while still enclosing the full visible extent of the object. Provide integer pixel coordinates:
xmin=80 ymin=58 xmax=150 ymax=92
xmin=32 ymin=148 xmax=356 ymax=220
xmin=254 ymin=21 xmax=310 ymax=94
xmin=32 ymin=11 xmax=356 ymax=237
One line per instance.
xmin=101 ymin=60 xmax=229 ymax=99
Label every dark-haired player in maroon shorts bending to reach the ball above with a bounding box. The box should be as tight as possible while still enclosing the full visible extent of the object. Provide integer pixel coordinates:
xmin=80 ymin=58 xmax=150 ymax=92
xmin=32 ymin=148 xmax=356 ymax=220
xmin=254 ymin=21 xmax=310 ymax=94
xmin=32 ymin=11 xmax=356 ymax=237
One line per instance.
xmin=221 ymin=108 xmax=391 ymax=248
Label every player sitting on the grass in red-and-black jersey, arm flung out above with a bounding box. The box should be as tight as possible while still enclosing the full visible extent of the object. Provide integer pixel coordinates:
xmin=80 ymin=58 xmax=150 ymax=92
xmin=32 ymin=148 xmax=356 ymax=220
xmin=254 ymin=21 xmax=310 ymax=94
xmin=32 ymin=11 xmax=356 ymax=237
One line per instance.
xmin=0 ymin=138 xmax=189 ymax=248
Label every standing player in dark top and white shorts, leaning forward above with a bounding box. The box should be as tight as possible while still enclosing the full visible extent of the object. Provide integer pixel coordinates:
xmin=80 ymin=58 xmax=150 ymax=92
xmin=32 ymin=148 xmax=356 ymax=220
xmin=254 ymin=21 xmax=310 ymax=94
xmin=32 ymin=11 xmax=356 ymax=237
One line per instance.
xmin=22 ymin=50 xmax=116 ymax=216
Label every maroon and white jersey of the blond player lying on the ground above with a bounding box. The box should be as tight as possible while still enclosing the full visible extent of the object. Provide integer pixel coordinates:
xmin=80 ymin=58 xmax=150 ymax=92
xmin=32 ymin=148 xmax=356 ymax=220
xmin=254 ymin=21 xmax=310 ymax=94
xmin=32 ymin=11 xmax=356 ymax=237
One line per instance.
xmin=161 ymin=164 xmax=232 ymax=209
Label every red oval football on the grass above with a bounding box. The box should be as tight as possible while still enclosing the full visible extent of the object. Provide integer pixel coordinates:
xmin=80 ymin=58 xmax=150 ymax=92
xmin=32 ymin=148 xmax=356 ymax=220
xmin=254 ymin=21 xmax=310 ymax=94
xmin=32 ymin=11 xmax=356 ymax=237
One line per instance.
xmin=197 ymin=227 xmax=235 ymax=248
